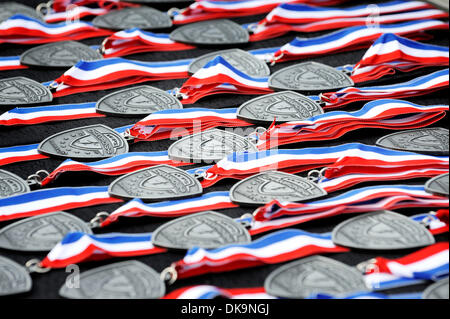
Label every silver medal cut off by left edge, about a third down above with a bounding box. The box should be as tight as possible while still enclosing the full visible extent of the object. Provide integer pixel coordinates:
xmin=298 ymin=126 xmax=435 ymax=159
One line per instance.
xmin=0 ymin=76 xmax=53 ymax=105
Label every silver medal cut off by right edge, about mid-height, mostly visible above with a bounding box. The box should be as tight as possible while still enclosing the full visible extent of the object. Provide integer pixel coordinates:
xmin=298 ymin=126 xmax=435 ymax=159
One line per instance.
xmin=376 ymin=127 xmax=448 ymax=155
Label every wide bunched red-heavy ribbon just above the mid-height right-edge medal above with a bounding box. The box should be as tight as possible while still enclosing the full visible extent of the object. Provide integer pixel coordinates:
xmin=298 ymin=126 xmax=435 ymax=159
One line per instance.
xmin=257 ymin=100 xmax=448 ymax=150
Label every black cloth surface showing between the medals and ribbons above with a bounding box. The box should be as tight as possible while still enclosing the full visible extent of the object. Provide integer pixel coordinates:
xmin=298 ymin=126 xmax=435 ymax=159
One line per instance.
xmin=0 ymin=0 xmax=448 ymax=298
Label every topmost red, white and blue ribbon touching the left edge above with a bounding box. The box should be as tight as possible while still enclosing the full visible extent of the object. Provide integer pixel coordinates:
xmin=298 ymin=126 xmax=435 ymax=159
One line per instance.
xmin=0 ymin=14 xmax=113 ymax=44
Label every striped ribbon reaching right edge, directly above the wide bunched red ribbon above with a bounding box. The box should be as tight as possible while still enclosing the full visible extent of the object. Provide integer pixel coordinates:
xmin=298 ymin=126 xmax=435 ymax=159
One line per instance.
xmin=320 ymin=69 xmax=449 ymax=108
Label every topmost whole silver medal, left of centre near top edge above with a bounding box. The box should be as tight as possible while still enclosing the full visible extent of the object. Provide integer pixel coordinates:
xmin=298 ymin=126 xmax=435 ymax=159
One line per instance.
xmin=92 ymin=7 xmax=172 ymax=30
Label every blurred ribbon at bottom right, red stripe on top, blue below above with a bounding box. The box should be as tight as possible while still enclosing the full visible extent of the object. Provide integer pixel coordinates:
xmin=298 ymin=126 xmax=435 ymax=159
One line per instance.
xmin=364 ymin=242 xmax=449 ymax=290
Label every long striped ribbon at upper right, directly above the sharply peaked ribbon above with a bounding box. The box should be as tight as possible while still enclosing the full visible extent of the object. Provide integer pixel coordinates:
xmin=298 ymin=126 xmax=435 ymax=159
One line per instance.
xmin=273 ymin=20 xmax=448 ymax=62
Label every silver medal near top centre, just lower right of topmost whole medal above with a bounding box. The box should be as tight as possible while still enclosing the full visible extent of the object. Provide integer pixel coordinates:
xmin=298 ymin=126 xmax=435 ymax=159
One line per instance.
xmin=170 ymin=19 xmax=249 ymax=45
